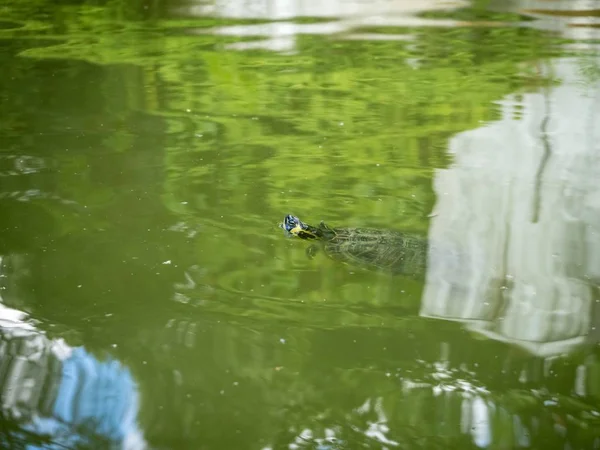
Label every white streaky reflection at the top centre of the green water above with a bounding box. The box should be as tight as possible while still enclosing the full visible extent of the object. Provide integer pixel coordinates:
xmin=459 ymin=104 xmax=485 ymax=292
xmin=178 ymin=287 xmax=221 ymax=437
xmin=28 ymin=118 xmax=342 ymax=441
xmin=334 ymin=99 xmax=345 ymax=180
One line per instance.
xmin=181 ymin=0 xmax=467 ymax=52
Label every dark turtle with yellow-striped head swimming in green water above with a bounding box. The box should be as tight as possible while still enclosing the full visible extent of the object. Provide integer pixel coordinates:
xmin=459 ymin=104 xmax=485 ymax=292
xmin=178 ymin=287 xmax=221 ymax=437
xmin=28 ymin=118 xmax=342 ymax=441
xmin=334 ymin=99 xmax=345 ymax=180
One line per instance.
xmin=280 ymin=214 xmax=427 ymax=277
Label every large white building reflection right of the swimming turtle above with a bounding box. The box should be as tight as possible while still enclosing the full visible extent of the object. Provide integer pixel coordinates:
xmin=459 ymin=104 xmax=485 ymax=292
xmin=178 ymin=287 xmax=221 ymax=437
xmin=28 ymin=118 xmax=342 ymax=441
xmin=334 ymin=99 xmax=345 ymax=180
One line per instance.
xmin=421 ymin=53 xmax=600 ymax=355
